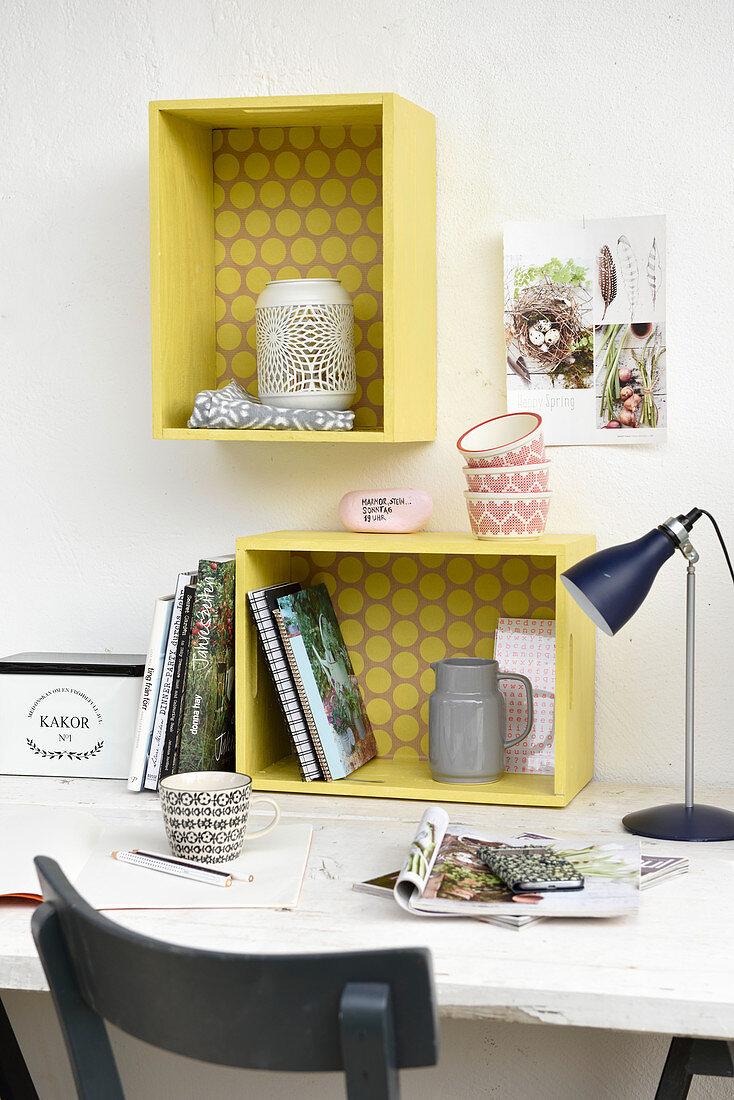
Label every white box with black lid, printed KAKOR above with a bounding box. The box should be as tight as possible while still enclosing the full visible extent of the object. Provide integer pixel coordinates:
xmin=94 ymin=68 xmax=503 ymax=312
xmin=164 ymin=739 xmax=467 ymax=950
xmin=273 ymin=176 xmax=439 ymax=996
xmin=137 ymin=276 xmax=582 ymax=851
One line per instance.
xmin=0 ymin=653 xmax=145 ymax=779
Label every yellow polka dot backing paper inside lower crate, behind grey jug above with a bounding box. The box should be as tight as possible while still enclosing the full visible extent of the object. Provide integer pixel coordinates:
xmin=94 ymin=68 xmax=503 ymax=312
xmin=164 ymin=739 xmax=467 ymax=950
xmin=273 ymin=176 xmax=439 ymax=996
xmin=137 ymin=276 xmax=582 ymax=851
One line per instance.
xmin=291 ymin=551 xmax=556 ymax=759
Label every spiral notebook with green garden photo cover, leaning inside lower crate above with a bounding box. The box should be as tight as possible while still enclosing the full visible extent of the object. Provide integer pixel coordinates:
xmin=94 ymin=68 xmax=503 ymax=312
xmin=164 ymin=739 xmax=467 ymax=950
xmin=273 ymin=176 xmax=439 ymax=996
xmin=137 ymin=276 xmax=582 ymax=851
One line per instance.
xmin=275 ymin=584 xmax=377 ymax=779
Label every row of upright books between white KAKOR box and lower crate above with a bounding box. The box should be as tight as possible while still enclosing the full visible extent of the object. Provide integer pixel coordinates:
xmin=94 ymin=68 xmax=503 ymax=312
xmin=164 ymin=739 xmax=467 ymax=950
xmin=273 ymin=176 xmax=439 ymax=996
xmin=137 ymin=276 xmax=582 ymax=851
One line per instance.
xmin=128 ymin=557 xmax=234 ymax=791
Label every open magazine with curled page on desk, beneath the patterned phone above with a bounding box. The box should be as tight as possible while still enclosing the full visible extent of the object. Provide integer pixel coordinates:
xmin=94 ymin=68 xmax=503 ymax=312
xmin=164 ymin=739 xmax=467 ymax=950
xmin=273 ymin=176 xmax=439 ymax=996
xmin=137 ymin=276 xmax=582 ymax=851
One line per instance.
xmin=354 ymin=806 xmax=688 ymax=927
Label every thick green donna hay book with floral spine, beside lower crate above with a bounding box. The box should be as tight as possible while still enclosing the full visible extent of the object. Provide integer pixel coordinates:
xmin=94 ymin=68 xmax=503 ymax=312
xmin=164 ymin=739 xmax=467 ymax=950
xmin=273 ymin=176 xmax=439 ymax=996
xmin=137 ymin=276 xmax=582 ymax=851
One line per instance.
xmin=177 ymin=557 xmax=234 ymax=772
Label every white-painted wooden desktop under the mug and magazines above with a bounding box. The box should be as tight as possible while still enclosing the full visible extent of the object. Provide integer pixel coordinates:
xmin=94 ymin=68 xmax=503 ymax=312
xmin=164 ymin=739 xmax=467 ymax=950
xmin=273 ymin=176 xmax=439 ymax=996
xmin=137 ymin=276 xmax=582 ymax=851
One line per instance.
xmin=0 ymin=777 xmax=734 ymax=1040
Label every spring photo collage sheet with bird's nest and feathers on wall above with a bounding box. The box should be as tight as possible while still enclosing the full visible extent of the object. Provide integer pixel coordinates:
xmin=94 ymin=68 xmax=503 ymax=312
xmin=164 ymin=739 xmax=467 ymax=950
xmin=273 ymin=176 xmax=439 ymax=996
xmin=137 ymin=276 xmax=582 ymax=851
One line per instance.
xmin=504 ymin=216 xmax=667 ymax=446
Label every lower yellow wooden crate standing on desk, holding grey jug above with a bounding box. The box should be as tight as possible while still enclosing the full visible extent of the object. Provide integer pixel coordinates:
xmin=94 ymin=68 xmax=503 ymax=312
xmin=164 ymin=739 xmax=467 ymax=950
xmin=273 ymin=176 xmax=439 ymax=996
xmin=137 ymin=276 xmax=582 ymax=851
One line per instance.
xmin=235 ymin=531 xmax=595 ymax=806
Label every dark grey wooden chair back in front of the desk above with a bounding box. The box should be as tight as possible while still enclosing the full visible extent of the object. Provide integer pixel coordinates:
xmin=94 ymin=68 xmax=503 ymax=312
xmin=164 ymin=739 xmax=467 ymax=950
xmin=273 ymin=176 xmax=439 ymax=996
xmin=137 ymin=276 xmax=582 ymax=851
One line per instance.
xmin=32 ymin=856 xmax=438 ymax=1100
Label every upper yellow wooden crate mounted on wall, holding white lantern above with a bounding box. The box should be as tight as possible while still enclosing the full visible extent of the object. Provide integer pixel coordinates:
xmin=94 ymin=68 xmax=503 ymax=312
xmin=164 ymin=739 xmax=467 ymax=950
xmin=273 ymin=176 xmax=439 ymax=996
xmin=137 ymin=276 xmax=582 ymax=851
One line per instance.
xmin=150 ymin=94 xmax=436 ymax=443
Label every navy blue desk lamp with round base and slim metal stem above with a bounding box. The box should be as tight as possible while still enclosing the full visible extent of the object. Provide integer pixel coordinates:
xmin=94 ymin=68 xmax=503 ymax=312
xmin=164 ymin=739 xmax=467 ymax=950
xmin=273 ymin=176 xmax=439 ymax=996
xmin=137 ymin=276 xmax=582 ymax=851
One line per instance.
xmin=561 ymin=508 xmax=734 ymax=840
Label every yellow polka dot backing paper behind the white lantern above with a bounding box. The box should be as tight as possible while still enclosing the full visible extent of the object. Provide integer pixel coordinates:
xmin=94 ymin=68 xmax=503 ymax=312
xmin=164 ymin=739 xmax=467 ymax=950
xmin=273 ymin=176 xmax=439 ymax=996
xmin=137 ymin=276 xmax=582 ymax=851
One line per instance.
xmin=211 ymin=125 xmax=384 ymax=429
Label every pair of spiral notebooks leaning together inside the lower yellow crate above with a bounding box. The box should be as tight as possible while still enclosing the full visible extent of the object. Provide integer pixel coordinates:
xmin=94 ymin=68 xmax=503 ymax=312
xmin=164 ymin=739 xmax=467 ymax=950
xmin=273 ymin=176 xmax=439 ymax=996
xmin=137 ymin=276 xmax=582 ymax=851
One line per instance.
xmin=248 ymin=583 xmax=377 ymax=782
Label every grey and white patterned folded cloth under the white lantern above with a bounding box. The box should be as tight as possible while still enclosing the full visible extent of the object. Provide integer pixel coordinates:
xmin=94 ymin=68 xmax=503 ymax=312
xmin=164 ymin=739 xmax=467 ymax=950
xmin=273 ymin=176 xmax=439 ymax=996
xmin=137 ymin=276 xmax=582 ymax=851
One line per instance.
xmin=188 ymin=382 xmax=354 ymax=431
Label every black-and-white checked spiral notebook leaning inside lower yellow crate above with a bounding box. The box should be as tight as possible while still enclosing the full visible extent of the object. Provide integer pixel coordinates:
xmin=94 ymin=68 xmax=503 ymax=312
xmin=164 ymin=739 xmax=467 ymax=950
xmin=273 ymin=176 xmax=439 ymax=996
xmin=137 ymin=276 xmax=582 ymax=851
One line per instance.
xmin=248 ymin=584 xmax=324 ymax=782
